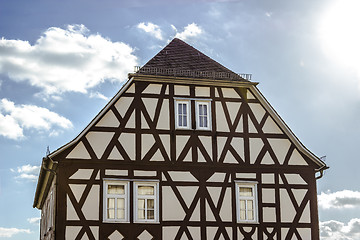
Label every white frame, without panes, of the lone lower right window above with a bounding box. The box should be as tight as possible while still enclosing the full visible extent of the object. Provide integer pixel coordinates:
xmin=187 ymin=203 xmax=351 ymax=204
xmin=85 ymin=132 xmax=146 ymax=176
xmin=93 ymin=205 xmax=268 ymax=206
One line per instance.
xmin=235 ymin=182 xmax=259 ymax=223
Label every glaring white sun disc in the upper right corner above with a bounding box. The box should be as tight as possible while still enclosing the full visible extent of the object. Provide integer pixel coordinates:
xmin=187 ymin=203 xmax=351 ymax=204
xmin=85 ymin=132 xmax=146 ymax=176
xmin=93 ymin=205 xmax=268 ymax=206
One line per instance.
xmin=319 ymin=0 xmax=360 ymax=69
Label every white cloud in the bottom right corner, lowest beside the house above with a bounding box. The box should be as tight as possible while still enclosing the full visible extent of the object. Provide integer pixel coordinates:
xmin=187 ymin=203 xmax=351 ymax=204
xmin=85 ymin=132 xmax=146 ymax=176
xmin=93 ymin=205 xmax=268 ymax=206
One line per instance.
xmin=320 ymin=218 xmax=360 ymax=240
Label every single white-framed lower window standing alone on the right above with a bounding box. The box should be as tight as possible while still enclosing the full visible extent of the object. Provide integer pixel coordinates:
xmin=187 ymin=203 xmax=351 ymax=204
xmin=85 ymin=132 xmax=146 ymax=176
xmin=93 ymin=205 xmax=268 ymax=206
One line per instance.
xmin=236 ymin=182 xmax=257 ymax=223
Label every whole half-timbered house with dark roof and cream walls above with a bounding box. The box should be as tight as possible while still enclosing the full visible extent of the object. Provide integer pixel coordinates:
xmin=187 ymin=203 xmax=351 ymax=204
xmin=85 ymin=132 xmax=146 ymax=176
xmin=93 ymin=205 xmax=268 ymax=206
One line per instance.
xmin=34 ymin=39 xmax=327 ymax=240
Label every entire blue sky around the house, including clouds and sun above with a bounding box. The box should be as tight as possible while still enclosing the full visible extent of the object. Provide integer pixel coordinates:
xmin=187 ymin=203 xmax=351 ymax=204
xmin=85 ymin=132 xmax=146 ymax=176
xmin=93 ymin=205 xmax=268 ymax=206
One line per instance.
xmin=0 ymin=0 xmax=360 ymax=240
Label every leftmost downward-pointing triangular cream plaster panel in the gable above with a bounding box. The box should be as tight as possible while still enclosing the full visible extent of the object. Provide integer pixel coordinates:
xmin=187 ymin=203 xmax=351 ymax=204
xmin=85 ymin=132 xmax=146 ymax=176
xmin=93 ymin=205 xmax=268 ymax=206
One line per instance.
xmin=86 ymin=132 xmax=115 ymax=159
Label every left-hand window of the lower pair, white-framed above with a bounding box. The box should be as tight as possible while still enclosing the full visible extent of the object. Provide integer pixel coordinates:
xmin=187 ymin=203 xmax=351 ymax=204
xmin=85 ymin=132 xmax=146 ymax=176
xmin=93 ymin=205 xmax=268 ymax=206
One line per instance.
xmin=104 ymin=181 xmax=129 ymax=222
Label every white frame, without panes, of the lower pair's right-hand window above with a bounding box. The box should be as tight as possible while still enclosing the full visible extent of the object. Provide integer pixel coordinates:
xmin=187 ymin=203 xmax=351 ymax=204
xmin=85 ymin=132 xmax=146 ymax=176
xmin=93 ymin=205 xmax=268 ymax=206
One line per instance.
xmin=133 ymin=180 xmax=159 ymax=223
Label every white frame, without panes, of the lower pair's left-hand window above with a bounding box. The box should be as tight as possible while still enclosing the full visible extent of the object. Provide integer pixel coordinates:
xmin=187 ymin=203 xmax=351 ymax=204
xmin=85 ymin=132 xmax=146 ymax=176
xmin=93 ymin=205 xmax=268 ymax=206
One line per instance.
xmin=103 ymin=180 xmax=130 ymax=222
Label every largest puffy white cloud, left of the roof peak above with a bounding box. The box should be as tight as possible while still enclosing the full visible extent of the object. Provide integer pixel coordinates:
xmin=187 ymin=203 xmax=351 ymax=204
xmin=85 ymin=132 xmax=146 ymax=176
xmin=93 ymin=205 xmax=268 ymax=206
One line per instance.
xmin=0 ymin=25 xmax=138 ymax=96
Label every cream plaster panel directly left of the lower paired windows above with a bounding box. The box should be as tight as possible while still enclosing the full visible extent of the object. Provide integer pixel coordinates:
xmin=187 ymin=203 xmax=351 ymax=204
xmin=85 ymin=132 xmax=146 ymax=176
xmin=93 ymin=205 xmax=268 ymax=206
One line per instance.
xmin=82 ymin=185 xmax=100 ymax=220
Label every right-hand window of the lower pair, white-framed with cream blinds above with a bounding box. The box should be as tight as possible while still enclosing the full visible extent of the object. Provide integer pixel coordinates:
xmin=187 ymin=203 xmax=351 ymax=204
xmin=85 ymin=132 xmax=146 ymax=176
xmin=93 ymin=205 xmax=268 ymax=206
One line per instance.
xmin=134 ymin=182 xmax=159 ymax=222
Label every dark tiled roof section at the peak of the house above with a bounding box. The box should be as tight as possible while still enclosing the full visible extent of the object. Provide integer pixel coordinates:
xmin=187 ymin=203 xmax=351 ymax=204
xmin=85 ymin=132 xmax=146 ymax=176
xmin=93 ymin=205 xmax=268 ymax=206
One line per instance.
xmin=137 ymin=38 xmax=248 ymax=81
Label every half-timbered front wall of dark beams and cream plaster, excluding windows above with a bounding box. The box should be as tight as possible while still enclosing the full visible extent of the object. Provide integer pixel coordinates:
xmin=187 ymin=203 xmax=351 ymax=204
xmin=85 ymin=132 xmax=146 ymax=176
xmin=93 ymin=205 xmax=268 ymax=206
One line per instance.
xmin=52 ymin=81 xmax=318 ymax=240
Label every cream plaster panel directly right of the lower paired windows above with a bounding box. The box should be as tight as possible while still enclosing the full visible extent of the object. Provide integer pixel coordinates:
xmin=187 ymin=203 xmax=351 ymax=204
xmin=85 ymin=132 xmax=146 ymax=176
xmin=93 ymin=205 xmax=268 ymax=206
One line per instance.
xmin=162 ymin=186 xmax=185 ymax=221
